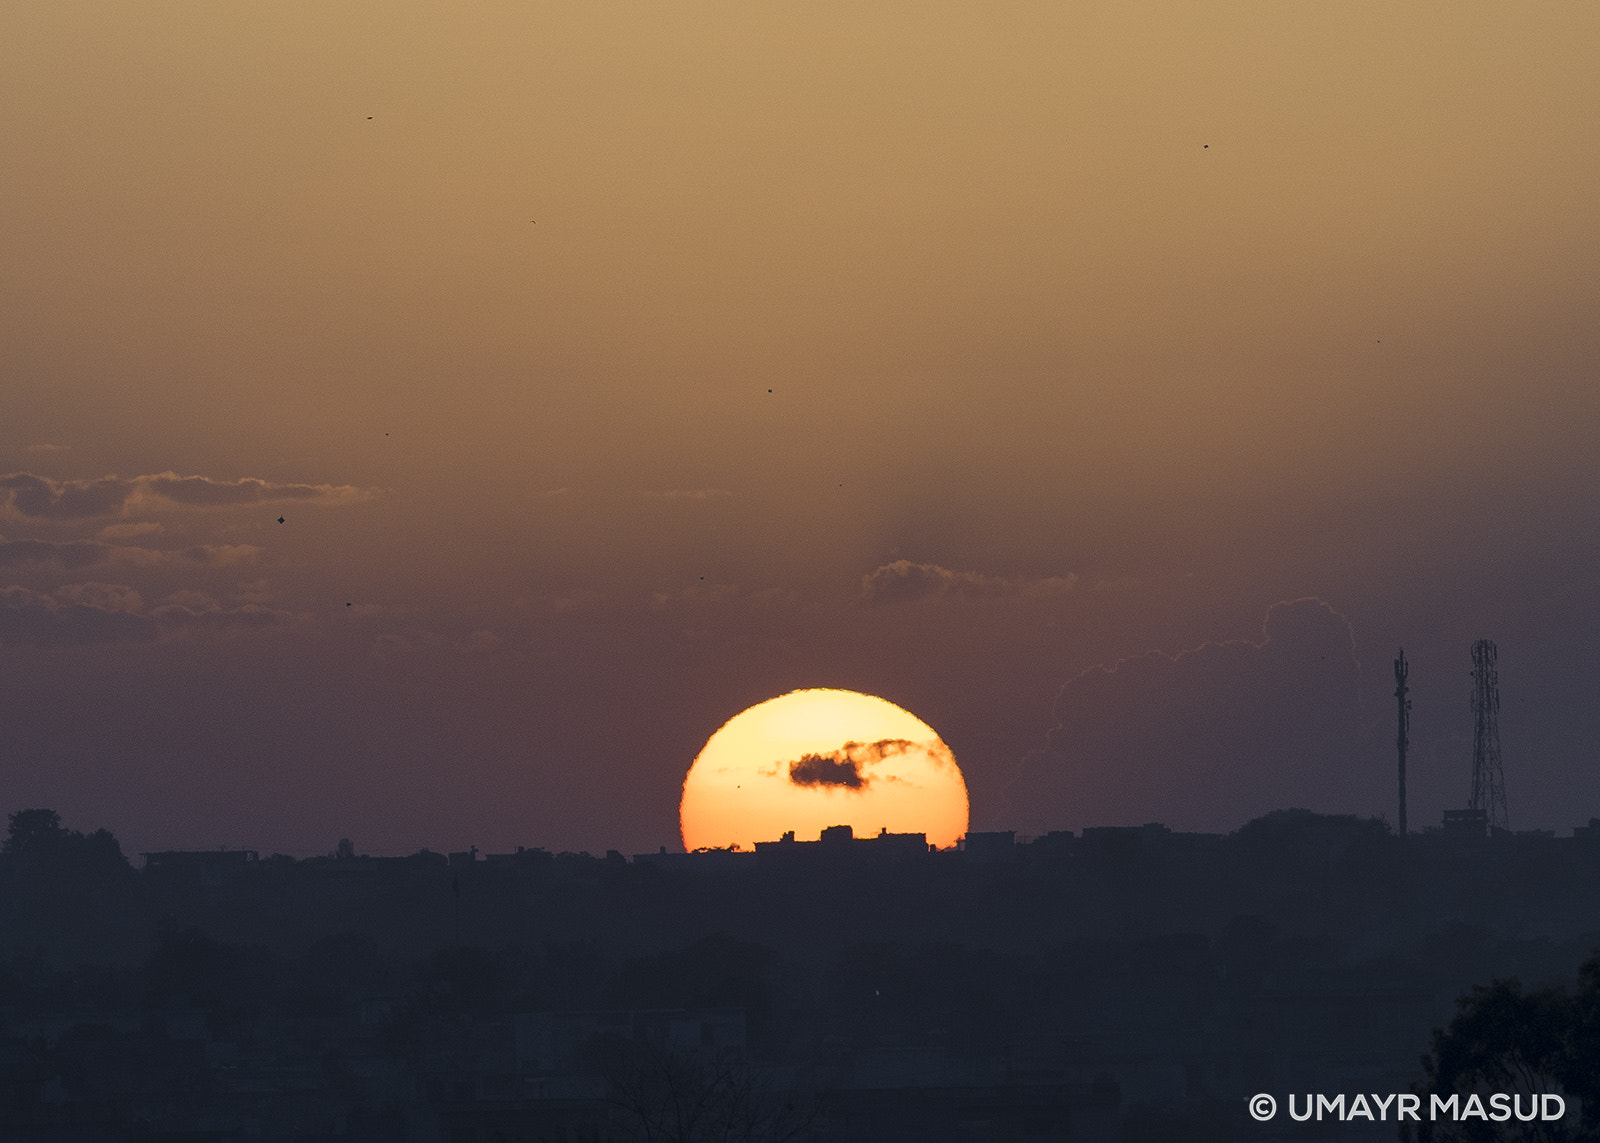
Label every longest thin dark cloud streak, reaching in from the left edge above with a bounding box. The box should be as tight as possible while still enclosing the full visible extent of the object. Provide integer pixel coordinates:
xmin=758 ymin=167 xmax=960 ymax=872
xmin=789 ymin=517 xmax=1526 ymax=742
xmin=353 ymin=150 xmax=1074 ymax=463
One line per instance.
xmin=0 ymin=472 xmax=376 ymax=520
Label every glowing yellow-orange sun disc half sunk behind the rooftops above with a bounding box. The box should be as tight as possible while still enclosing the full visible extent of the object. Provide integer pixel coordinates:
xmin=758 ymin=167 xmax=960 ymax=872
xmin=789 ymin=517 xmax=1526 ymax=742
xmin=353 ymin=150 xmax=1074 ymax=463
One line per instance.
xmin=680 ymin=690 xmax=966 ymax=850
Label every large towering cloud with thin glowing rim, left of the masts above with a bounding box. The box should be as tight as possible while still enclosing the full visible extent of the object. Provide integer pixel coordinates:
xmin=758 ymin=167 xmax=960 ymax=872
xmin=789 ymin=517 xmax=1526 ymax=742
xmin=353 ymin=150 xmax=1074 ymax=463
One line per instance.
xmin=1008 ymin=599 xmax=1386 ymax=832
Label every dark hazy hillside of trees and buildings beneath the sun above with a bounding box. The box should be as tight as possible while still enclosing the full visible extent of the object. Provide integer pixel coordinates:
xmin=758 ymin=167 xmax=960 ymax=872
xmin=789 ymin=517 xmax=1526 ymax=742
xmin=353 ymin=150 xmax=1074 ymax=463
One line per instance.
xmin=18 ymin=810 xmax=1600 ymax=1143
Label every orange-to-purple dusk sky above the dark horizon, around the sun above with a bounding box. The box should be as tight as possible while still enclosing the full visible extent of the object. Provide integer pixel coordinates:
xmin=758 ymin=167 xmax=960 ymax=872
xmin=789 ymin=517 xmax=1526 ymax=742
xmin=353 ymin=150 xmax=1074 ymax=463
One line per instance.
xmin=0 ymin=0 xmax=1600 ymax=853
